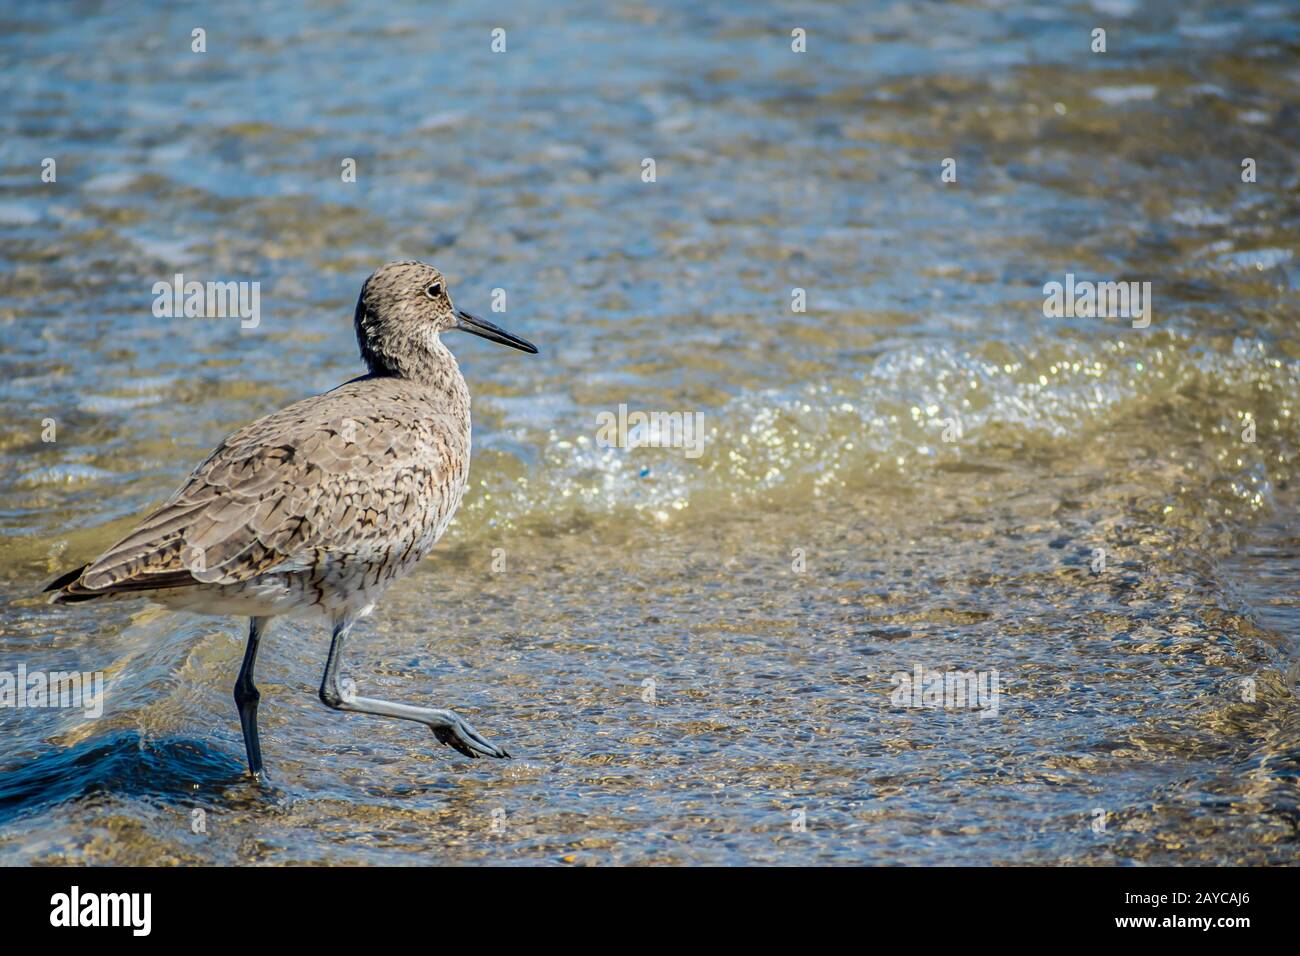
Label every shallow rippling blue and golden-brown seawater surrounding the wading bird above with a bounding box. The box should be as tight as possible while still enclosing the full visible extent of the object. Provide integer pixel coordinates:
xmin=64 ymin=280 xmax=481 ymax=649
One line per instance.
xmin=0 ymin=0 xmax=1300 ymax=865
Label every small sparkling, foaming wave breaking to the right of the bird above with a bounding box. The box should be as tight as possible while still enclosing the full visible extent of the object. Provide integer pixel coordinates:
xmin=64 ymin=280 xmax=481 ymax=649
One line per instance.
xmin=463 ymin=332 xmax=1300 ymax=527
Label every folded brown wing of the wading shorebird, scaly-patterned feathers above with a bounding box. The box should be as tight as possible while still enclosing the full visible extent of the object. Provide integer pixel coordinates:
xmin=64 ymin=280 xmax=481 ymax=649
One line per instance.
xmin=64 ymin=382 xmax=456 ymax=597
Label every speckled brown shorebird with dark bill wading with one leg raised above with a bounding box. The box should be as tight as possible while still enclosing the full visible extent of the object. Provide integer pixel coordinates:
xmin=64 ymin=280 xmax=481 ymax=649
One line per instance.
xmin=46 ymin=261 xmax=537 ymax=780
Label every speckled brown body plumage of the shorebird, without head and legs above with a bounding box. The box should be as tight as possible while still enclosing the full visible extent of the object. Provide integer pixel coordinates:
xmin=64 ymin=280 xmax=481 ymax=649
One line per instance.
xmin=62 ymin=371 xmax=469 ymax=610
